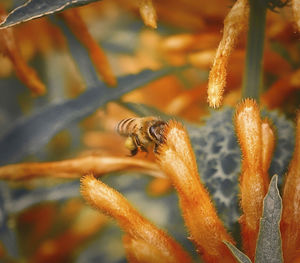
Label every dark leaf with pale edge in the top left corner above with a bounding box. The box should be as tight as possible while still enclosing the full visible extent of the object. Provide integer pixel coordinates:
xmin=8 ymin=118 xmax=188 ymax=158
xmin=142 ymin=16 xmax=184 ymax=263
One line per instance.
xmin=0 ymin=0 xmax=99 ymax=28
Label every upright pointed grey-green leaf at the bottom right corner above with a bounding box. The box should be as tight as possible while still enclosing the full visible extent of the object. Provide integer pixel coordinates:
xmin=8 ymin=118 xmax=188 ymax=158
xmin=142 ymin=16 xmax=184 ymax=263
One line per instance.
xmin=255 ymin=175 xmax=283 ymax=263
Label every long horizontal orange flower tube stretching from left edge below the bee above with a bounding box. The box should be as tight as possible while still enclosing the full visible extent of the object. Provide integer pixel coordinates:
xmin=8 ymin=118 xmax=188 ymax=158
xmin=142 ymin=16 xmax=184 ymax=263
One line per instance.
xmin=0 ymin=156 xmax=165 ymax=180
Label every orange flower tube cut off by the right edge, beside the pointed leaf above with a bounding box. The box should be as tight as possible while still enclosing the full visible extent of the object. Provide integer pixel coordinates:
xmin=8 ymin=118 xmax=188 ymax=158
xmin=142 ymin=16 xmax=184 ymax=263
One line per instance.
xmin=281 ymin=111 xmax=300 ymax=262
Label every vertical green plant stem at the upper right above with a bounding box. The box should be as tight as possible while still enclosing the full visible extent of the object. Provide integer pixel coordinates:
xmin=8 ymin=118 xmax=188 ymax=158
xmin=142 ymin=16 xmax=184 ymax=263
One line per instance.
xmin=243 ymin=0 xmax=267 ymax=101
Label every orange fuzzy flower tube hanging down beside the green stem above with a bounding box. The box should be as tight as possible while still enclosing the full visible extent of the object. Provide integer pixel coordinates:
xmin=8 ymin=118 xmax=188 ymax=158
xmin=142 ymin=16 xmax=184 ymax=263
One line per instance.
xmin=207 ymin=0 xmax=249 ymax=108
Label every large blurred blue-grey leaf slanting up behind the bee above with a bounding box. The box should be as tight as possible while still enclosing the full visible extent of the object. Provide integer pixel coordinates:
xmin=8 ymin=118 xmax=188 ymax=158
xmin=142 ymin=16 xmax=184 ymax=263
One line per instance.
xmin=0 ymin=68 xmax=171 ymax=165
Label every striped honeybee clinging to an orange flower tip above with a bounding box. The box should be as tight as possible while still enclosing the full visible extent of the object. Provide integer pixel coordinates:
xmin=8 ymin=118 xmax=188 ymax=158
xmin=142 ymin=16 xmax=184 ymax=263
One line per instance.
xmin=116 ymin=116 xmax=166 ymax=156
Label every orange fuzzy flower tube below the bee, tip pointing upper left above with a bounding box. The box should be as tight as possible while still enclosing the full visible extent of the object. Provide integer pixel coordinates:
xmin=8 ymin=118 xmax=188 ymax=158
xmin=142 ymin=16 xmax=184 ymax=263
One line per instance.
xmin=81 ymin=175 xmax=191 ymax=263
